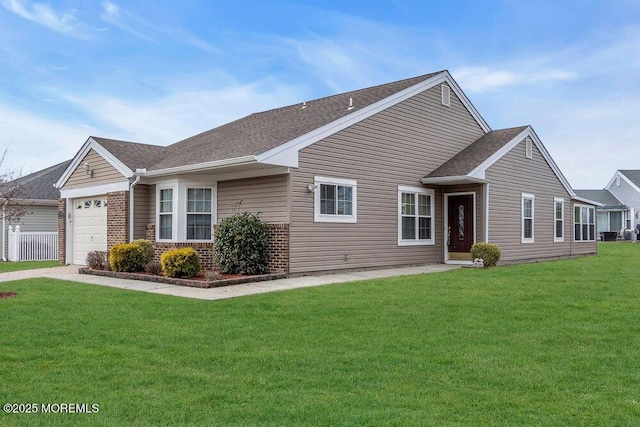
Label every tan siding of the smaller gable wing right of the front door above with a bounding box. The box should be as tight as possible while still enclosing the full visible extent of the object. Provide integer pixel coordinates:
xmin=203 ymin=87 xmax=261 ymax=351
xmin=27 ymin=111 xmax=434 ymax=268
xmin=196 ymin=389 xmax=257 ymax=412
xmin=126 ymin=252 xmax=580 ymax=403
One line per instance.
xmin=486 ymin=140 xmax=596 ymax=262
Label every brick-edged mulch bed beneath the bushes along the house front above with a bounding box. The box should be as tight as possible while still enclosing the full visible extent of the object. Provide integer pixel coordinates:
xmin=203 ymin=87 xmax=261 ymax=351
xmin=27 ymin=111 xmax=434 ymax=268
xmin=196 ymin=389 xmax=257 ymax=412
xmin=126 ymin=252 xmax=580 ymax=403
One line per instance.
xmin=78 ymin=268 xmax=287 ymax=288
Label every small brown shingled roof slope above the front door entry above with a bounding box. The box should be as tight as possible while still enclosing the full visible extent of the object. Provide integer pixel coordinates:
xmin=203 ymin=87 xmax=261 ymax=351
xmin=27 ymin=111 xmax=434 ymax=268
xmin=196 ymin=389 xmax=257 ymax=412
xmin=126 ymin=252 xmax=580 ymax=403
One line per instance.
xmin=425 ymin=126 xmax=527 ymax=178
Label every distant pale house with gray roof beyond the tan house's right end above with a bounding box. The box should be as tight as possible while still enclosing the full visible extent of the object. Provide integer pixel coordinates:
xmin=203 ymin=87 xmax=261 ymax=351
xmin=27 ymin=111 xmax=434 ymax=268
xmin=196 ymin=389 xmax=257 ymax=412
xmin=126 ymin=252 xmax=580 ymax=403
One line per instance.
xmin=576 ymin=190 xmax=634 ymax=240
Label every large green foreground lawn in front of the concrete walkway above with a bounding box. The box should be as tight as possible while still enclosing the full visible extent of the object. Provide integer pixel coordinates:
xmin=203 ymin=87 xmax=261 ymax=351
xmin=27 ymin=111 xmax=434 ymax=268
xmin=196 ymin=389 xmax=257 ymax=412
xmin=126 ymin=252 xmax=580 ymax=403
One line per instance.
xmin=0 ymin=244 xmax=640 ymax=426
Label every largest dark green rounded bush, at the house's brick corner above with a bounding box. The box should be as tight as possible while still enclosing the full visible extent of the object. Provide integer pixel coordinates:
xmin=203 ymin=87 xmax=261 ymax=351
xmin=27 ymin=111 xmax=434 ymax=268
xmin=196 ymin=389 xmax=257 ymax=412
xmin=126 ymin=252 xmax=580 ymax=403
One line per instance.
xmin=214 ymin=212 xmax=269 ymax=274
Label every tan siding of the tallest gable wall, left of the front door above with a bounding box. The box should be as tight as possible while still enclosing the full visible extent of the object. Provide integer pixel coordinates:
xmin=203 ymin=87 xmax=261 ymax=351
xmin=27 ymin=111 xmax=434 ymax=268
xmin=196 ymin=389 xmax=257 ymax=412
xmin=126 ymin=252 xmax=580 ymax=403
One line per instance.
xmin=290 ymin=86 xmax=483 ymax=273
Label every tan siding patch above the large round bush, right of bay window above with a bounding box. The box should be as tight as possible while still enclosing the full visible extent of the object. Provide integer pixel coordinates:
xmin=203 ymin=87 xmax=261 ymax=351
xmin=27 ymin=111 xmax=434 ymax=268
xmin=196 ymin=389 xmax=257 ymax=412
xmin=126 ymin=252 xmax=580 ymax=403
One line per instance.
xmin=218 ymin=175 xmax=289 ymax=223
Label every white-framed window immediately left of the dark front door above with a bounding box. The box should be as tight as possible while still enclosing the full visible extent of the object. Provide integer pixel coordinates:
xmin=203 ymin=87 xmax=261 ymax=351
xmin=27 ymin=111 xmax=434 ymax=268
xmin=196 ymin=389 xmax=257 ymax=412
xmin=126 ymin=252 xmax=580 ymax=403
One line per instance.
xmin=398 ymin=186 xmax=435 ymax=246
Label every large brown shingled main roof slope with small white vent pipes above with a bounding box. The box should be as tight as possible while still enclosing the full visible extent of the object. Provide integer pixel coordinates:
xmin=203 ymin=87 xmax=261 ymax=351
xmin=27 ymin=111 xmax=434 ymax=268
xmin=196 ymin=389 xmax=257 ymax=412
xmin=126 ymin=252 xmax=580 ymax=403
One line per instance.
xmin=148 ymin=71 xmax=441 ymax=170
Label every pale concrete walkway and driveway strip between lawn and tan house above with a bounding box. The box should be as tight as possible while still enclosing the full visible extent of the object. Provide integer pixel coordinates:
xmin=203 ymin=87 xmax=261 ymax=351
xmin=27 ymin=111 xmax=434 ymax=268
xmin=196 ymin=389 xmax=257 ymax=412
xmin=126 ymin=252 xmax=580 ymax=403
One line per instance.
xmin=0 ymin=264 xmax=459 ymax=300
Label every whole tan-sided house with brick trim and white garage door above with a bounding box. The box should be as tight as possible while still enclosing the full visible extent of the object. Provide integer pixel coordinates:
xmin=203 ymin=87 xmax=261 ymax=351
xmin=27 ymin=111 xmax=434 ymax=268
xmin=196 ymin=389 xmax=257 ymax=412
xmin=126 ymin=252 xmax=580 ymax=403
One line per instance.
xmin=56 ymin=71 xmax=596 ymax=274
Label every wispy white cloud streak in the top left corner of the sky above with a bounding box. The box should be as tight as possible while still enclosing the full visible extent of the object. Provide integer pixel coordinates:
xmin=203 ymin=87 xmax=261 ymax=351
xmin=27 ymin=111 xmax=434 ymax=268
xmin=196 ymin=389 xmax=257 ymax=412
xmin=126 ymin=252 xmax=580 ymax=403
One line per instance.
xmin=1 ymin=0 xmax=89 ymax=39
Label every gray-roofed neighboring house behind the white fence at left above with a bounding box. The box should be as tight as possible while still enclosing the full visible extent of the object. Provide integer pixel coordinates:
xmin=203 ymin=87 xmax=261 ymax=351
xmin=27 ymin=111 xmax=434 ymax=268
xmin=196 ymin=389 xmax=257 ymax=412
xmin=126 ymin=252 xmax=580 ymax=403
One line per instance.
xmin=2 ymin=160 xmax=71 ymax=259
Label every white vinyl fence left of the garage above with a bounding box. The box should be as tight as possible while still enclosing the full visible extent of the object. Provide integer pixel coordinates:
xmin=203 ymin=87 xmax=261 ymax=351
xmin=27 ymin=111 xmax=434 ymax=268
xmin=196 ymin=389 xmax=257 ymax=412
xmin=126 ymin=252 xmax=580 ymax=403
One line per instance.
xmin=9 ymin=225 xmax=58 ymax=261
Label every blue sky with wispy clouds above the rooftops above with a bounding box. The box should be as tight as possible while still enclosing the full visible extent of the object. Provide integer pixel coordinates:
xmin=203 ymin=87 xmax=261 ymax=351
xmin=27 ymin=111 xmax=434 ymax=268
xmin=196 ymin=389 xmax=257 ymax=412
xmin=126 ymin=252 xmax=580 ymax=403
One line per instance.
xmin=0 ymin=0 xmax=640 ymax=188
